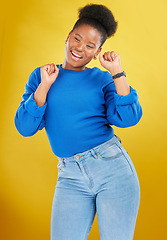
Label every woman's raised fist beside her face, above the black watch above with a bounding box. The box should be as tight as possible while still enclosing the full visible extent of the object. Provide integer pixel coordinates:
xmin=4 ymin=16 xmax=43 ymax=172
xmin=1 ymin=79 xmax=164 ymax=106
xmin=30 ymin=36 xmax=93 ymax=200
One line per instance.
xmin=99 ymin=51 xmax=123 ymax=75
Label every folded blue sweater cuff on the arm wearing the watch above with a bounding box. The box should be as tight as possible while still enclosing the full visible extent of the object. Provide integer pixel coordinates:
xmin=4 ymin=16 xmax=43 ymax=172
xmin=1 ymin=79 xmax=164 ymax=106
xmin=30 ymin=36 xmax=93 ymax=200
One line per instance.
xmin=114 ymin=86 xmax=138 ymax=105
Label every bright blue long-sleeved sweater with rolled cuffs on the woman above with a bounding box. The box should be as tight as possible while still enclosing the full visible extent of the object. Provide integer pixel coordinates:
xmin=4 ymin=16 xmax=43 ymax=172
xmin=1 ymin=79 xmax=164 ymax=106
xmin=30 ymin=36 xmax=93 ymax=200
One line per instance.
xmin=15 ymin=65 xmax=142 ymax=157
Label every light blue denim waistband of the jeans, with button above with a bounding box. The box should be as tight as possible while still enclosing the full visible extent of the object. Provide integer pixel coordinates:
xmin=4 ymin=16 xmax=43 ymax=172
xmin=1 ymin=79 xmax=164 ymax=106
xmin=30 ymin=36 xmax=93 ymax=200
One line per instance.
xmin=57 ymin=134 xmax=121 ymax=162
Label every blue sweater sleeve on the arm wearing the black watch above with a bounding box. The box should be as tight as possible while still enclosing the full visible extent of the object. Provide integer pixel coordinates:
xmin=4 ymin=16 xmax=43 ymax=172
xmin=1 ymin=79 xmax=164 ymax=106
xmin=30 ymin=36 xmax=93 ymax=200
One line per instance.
xmin=103 ymin=80 xmax=142 ymax=128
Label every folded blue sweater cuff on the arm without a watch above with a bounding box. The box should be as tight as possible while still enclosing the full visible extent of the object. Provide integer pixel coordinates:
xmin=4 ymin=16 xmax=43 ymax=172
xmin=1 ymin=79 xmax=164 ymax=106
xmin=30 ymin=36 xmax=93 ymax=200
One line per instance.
xmin=24 ymin=93 xmax=47 ymax=117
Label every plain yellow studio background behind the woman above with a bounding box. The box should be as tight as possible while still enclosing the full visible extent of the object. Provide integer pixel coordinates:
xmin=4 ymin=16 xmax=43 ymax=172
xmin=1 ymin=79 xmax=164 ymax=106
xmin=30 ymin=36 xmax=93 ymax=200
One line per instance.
xmin=0 ymin=0 xmax=167 ymax=240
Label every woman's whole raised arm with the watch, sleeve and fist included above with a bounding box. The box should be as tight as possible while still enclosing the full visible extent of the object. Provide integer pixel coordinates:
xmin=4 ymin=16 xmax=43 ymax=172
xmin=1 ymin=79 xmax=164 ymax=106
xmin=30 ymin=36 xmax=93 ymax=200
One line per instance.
xmin=99 ymin=51 xmax=142 ymax=128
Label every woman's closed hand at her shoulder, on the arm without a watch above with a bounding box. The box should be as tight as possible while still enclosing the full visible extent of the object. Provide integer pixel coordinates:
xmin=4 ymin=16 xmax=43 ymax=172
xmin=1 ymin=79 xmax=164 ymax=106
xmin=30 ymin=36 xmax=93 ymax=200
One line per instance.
xmin=41 ymin=63 xmax=59 ymax=88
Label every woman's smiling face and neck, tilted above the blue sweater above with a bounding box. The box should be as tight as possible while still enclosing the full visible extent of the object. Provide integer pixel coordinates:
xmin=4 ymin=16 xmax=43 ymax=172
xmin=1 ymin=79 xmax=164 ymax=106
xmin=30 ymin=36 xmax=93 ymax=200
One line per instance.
xmin=62 ymin=24 xmax=101 ymax=71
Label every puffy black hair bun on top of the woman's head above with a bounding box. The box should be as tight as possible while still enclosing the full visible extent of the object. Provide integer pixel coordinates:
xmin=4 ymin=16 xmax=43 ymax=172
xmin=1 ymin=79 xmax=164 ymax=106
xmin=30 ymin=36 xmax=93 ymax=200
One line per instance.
xmin=78 ymin=4 xmax=117 ymax=37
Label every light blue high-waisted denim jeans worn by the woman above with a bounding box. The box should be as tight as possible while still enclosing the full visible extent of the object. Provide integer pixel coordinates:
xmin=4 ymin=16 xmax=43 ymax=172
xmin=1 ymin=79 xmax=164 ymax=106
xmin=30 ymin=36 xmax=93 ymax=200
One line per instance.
xmin=51 ymin=135 xmax=140 ymax=240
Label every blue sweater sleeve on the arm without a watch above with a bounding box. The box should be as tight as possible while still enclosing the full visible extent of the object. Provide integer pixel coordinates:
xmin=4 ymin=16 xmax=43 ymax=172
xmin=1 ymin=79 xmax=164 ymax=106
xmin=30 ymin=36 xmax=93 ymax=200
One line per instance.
xmin=14 ymin=68 xmax=47 ymax=137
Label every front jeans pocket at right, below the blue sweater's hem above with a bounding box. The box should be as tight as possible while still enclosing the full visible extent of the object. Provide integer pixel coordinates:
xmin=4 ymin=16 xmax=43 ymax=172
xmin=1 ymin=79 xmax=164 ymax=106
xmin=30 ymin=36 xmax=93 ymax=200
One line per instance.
xmin=97 ymin=143 xmax=123 ymax=160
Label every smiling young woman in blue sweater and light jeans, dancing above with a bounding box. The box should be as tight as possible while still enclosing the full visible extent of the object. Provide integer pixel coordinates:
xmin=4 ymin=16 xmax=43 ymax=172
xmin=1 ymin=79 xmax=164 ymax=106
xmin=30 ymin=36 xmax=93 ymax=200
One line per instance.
xmin=15 ymin=4 xmax=142 ymax=240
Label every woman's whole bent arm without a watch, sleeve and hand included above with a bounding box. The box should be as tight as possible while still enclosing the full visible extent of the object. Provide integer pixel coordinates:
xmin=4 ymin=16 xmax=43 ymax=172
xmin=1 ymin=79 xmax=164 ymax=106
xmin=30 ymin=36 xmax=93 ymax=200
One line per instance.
xmin=15 ymin=64 xmax=59 ymax=137
